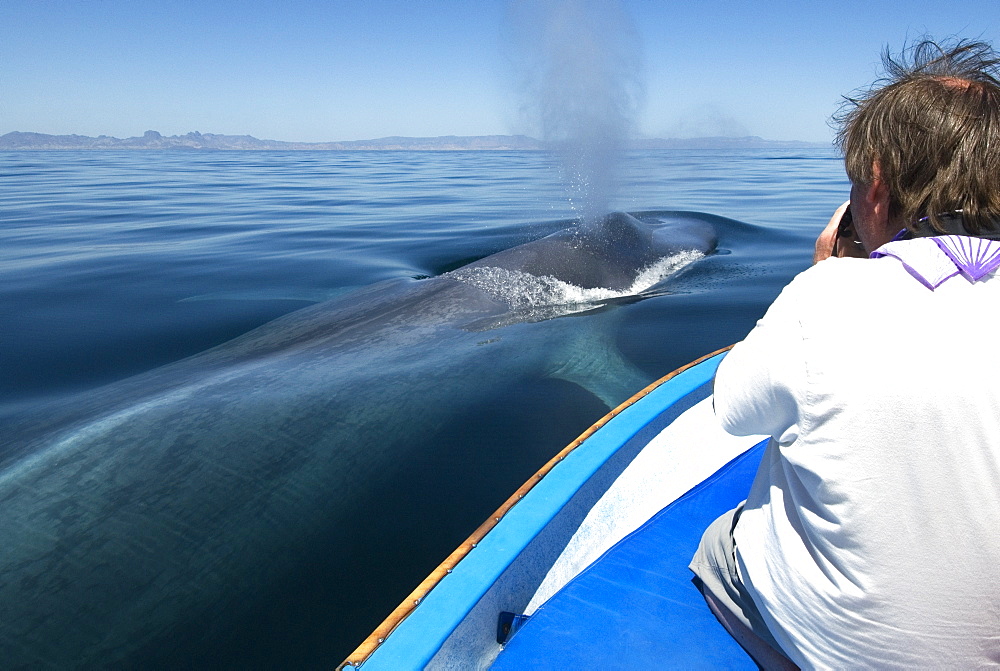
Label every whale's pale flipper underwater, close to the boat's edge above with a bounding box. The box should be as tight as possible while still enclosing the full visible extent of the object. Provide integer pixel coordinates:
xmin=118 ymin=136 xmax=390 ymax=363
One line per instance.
xmin=545 ymin=329 xmax=653 ymax=410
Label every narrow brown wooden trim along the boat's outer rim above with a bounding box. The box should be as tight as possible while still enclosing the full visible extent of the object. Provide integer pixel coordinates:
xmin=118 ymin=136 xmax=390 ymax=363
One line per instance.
xmin=337 ymin=345 xmax=733 ymax=671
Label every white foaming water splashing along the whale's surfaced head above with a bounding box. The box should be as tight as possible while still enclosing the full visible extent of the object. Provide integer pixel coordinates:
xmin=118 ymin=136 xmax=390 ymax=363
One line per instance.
xmin=447 ymin=250 xmax=705 ymax=317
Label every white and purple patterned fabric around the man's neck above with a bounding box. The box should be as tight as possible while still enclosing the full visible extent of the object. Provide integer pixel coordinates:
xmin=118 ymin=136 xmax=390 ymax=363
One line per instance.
xmin=871 ymin=235 xmax=1000 ymax=290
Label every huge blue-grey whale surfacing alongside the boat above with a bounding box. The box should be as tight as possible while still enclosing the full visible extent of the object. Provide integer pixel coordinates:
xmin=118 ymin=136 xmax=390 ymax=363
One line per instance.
xmin=0 ymin=213 xmax=716 ymax=669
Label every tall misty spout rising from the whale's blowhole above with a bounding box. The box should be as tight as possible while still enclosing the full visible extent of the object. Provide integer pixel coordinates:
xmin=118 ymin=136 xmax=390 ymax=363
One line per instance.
xmin=510 ymin=0 xmax=643 ymax=223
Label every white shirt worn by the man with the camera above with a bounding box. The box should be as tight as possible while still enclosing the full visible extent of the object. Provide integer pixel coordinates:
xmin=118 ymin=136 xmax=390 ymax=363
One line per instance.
xmin=715 ymin=249 xmax=1000 ymax=668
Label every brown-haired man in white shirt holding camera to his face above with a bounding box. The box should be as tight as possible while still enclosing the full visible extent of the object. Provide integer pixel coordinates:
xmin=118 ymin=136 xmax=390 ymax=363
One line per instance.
xmin=691 ymin=41 xmax=1000 ymax=668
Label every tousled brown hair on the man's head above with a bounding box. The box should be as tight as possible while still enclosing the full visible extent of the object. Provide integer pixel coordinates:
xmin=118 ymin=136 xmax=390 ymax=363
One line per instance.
xmin=834 ymin=40 xmax=1000 ymax=235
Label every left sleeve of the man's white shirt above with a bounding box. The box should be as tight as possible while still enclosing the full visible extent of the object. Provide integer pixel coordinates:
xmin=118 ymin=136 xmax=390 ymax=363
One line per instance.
xmin=714 ymin=271 xmax=808 ymax=445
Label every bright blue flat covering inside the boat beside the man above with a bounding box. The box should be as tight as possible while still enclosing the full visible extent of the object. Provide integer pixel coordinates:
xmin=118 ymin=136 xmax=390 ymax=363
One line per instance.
xmin=492 ymin=443 xmax=764 ymax=671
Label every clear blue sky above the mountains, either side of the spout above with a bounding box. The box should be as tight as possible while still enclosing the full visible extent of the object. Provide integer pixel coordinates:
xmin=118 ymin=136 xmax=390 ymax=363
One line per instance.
xmin=0 ymin=0 xmax=1000 ymax=141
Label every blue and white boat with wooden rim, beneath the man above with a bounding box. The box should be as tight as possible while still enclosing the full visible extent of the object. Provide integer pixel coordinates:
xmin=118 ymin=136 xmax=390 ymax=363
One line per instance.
xmin=340 ymin=353 xmax=760 ymax=671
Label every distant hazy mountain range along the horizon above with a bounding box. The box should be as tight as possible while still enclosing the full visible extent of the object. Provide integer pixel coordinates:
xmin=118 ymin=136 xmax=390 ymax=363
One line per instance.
xmin=0 ymin=130 xmax=829 ymax=151
